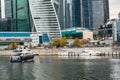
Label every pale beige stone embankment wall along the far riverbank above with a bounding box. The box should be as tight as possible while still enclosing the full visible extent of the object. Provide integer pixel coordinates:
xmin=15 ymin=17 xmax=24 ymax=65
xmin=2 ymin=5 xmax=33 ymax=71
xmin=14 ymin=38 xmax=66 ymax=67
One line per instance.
xmin=0 ymin=47 xmax=120 ymax=56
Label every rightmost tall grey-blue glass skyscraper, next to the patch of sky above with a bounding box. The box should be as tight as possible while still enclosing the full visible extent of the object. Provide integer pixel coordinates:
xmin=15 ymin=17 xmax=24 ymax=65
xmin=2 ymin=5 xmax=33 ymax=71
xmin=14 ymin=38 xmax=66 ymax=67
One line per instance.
xmin=92 ymin=0 xmax=109 ymax=31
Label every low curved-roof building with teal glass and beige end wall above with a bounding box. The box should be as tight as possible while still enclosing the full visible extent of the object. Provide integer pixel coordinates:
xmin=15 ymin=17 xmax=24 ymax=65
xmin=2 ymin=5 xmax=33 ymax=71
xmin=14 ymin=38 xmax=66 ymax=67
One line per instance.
xmin=62 ymin=28 xmax=93 ymax=40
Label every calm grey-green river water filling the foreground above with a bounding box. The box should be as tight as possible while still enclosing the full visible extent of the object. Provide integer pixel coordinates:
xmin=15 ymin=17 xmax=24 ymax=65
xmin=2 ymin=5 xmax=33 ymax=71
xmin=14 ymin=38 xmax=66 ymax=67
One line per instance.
xmin=0 ymin=56 xmax=120 ymax=80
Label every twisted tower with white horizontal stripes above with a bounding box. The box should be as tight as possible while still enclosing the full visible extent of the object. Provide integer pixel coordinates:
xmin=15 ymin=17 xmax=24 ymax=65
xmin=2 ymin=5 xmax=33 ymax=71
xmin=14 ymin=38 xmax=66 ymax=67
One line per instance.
xmin=29 ymin=0 xmax=61 ymax=38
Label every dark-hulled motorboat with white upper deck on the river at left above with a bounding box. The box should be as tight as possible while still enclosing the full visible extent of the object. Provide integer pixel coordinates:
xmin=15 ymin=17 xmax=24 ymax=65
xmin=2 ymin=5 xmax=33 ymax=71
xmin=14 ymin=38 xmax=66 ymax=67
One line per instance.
xmin=10 ymin=46 xmax=35 ymax=62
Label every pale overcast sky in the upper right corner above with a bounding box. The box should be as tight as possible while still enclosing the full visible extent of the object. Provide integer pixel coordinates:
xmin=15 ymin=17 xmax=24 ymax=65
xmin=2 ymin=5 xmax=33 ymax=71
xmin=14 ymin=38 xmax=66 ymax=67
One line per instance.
xmin=109 ymin=0 xmax=120 ymax=19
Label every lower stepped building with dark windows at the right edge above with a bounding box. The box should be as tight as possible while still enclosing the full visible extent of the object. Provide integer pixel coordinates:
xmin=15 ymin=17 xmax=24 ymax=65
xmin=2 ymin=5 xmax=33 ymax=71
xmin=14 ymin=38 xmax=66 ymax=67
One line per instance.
xmin=99 ymin=19 xmax=120 ymax=43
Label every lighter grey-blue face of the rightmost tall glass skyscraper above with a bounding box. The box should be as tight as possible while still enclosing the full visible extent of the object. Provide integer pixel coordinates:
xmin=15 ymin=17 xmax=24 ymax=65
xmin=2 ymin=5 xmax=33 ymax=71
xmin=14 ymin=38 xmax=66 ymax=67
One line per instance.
xmin=92 ymin=0 xmax=104 ymax=30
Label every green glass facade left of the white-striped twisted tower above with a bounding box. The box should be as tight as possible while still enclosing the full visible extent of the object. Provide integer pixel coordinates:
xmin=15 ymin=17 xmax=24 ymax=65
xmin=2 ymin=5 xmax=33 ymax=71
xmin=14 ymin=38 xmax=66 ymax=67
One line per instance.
xmin=12 ymin=0 xmax=31 ymax=32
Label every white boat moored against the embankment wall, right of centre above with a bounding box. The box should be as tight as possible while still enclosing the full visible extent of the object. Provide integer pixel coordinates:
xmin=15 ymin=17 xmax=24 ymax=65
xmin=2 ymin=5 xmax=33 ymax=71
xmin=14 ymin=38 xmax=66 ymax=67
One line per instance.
xmin=79 ymin=49 xmax=101 ymax=56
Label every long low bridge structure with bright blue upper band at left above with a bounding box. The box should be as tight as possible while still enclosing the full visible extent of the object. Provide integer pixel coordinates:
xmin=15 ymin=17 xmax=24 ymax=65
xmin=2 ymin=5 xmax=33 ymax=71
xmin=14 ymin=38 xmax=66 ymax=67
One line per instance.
xmin=0 ymin=32 xmax=31 ymax=43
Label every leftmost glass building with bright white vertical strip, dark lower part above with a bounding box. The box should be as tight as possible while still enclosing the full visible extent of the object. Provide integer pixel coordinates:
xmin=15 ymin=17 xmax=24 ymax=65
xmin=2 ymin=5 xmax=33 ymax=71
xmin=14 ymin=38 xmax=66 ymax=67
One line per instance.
xmin=0 ymin=0 xmax=12 ymax=31
